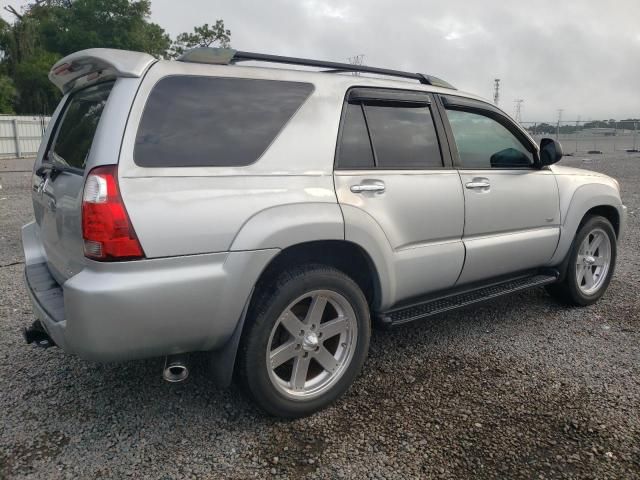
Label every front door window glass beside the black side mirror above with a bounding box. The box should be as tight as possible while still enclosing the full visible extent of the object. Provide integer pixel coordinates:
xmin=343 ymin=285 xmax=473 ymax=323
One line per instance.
xmin=447 ymin=110 xmax=533 ymax=168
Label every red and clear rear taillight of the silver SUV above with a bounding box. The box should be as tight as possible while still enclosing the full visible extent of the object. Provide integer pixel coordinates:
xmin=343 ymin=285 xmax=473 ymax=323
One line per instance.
xmin=82 ymin=165 xmax=144 ymax=261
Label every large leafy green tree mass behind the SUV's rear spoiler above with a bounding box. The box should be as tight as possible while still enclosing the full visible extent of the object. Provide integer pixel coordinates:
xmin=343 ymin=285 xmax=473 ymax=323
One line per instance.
xmin=0 ymin=0 xmax=171 ymax=113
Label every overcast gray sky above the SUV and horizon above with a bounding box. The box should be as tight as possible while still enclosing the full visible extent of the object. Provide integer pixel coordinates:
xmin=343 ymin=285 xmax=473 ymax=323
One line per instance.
xmin=2 ymin=0 xmax=640 ymax=121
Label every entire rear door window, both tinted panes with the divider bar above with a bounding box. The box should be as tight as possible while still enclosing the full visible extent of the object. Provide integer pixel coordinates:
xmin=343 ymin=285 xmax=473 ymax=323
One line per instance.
xmin=336 ymin=93 xmax=443 ymax=169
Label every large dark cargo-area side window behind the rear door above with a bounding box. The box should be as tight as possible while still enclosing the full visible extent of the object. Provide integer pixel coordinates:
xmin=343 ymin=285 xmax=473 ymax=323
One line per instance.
xmin=134 ymin=76 xmax=313 ymax=167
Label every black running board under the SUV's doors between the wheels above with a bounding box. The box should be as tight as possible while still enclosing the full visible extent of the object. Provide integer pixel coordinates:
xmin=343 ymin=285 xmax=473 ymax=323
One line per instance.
xmin=378 ymin=272 xmax=558 ymax=326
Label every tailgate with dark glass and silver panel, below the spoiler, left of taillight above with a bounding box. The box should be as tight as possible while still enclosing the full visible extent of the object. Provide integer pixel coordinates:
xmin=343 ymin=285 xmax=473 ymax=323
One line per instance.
xmin=32 ymin=82 xmax=114 ymax=283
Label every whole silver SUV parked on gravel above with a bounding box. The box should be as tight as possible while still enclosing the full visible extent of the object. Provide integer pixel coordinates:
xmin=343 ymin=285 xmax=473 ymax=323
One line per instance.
xmin=22 ymin=49 xmax=626 ymax=417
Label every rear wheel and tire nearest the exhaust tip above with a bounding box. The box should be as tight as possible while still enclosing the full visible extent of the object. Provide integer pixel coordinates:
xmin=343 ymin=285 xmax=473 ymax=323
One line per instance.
xmin=238 ymin=265 xmax=371 ymax=418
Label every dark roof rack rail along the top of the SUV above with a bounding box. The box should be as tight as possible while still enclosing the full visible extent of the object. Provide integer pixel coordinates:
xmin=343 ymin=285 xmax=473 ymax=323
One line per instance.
xmin=178 ymin=47 xmax=455 ymax=90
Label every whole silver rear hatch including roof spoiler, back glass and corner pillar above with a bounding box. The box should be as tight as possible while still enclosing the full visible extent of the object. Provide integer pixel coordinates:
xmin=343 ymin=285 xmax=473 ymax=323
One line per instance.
xmin=32 ymin=48 xmax=157 ymax=284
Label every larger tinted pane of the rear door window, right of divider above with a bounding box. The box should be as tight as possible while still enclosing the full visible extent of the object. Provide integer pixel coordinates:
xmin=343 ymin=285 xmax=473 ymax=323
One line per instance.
xmin=364 ymin=103 xmax=442 ymax=169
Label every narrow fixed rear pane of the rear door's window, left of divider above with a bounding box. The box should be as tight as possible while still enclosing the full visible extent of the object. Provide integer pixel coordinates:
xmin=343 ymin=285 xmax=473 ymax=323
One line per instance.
xmin=338 ymin=103 xmax=374 ymax=168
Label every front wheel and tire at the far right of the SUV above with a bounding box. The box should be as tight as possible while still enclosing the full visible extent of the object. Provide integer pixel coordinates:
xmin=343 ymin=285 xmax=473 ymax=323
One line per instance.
xmin=547 ymin=216 xmax=617 ymax=306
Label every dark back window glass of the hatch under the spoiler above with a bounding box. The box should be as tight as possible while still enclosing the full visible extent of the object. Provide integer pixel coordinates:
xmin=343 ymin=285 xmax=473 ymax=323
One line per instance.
xmin=48 ymin=82 xmax=113 ymax=169
